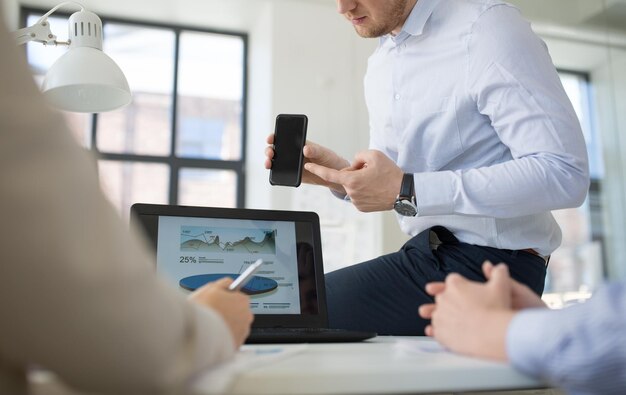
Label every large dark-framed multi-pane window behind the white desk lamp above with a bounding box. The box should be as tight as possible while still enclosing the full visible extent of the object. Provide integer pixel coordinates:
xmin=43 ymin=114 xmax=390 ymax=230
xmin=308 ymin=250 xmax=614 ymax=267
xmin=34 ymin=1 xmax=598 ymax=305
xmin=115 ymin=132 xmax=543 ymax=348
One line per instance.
xmin=22 ymin=8 xmax=247 ymax=217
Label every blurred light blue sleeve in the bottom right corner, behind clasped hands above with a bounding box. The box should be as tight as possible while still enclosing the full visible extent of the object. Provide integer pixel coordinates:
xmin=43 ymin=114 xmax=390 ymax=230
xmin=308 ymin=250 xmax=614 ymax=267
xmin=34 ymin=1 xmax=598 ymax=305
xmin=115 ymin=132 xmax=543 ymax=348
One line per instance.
xmin=507 ymin=283 xmax=626 ymax=394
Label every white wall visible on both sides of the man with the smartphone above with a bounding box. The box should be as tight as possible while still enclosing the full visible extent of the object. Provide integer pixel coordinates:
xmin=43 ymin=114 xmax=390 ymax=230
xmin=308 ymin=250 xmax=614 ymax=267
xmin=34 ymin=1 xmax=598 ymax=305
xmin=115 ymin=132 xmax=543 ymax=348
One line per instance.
xmin=2 ymin=0 xmax=626 ymax=277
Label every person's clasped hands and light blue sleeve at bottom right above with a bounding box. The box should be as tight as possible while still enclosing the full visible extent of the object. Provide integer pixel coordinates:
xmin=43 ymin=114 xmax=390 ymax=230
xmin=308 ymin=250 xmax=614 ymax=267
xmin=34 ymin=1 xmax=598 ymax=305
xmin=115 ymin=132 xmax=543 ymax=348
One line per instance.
xmin=420 ymin=263 xmax=626 ymax=395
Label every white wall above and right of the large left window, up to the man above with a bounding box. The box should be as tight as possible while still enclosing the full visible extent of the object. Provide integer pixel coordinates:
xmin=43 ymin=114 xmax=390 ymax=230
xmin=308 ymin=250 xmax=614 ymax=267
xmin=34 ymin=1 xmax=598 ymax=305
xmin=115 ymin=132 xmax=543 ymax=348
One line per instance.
xmin=5 ymin=0 xmax=386 ymax=269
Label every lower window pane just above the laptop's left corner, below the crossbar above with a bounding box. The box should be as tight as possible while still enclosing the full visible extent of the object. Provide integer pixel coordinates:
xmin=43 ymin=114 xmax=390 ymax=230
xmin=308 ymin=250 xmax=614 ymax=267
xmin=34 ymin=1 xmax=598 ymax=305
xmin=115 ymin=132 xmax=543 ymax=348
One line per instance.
xmin=99 ymin=160 xmax=170 ymax=217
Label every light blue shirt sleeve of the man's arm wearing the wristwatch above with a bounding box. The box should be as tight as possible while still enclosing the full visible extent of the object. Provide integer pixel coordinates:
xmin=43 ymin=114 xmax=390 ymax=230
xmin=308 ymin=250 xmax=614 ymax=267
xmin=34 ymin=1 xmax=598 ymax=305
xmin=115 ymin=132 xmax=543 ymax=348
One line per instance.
xmin=415 ymin=5 xmax=589 ymax=218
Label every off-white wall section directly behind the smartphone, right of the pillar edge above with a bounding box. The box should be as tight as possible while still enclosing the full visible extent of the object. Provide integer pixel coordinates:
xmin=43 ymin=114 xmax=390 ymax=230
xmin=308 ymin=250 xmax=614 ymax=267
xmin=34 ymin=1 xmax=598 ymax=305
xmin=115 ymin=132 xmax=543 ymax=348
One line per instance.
xmin=260 ymin=0 xmax=383 ymax=270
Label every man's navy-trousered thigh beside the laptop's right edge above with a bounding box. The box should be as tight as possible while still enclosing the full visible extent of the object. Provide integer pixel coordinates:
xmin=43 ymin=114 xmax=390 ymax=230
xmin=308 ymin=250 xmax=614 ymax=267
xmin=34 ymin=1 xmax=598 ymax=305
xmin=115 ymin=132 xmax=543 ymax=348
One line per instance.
xmin=326 ymin=229 xmax=446 ymax=335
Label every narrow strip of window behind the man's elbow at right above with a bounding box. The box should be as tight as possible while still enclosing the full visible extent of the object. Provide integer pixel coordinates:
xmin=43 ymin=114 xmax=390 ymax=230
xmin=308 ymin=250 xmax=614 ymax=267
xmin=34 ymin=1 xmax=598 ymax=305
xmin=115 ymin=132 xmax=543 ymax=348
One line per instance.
xmin=546 ymin=71 xmax=605 ymax=298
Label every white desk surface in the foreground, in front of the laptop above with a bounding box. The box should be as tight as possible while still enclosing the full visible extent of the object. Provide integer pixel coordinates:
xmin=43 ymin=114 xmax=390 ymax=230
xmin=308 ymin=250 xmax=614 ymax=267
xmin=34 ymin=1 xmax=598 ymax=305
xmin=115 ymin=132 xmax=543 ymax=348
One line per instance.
xmin=196 ymin=337 xmax=545 ymax=395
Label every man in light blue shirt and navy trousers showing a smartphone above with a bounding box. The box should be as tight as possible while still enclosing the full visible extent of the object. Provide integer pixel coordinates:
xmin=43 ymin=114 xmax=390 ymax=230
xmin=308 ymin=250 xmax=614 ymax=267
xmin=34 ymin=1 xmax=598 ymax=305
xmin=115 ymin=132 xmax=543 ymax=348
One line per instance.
xmin=265 ymin=0 xmax=589 ymax=335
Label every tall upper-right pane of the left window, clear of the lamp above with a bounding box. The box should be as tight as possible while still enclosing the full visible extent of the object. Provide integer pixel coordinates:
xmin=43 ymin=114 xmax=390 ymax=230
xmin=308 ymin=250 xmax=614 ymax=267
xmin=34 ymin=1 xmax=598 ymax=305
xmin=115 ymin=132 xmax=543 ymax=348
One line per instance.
xmin=176 ymin=32 xmax=244 ymax=160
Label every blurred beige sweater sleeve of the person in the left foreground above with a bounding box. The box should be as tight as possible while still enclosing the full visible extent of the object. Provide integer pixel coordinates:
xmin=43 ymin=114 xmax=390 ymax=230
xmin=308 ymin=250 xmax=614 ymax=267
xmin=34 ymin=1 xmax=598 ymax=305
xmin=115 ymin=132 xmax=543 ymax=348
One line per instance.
xmin=0 ymin=7 xmax=234 ymax=394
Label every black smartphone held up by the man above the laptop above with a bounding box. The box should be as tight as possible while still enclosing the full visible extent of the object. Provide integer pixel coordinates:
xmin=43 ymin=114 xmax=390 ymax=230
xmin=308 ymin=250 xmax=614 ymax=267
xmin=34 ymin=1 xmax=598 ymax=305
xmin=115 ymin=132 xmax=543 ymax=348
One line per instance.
xmin=270 ymin=114 xmax=308 ymax=187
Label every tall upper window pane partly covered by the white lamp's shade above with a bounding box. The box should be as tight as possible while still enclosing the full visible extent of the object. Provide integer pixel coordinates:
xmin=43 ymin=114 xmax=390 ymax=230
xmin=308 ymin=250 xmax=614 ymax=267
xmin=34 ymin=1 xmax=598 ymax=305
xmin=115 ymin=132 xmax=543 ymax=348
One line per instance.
xmin=97 ymin=23 xmax=175 ymax=156
